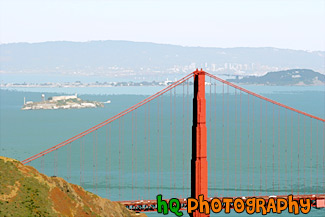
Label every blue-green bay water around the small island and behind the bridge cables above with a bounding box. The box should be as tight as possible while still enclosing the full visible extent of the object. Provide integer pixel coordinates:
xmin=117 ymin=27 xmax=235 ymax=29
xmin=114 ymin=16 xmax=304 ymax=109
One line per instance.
xmin=0 ymin=86 xmax=325 ymax=216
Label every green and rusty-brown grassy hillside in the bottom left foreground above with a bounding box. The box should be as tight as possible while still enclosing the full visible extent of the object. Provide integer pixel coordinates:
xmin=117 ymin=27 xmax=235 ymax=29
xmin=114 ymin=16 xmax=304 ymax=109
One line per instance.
xmin=0 ymin=157 xmax=145 ymax=217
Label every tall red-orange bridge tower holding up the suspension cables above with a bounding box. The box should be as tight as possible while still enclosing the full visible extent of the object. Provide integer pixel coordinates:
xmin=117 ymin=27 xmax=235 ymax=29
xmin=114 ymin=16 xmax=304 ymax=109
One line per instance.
xmin=191 ymin=69 xmax=209 ymax=217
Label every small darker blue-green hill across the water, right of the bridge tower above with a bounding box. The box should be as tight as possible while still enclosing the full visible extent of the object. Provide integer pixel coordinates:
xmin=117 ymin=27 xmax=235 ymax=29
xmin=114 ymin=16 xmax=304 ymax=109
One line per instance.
xmin=228 ymin=69 xmax=325 ymax=85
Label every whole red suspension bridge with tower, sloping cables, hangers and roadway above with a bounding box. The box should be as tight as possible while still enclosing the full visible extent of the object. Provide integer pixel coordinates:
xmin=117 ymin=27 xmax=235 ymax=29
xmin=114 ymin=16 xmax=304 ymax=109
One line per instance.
xmin=22 ymin=69 xmax=325 ymax=216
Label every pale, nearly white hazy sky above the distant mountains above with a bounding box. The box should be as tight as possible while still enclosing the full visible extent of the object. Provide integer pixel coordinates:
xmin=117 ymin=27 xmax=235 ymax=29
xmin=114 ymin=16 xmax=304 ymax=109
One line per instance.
xmin=0 ymin=0 xmax=325 ymax=50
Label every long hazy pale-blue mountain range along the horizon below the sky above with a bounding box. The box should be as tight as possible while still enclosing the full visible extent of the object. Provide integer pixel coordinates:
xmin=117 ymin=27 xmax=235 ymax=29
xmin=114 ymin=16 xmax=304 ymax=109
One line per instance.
xmin=0 ymin=41 xmax=325 ymax=76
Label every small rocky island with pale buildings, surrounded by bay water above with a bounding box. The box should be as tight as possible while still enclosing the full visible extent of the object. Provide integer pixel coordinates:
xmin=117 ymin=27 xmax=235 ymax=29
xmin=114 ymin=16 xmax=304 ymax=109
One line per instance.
xmin=22 ymin=94 xmax=105 ymax=110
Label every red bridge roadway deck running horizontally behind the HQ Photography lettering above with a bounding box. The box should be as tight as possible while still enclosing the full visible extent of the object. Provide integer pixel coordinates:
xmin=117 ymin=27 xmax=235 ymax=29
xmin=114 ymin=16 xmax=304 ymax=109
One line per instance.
xmin=117 ymin=194 xmax=325 ymax=212
